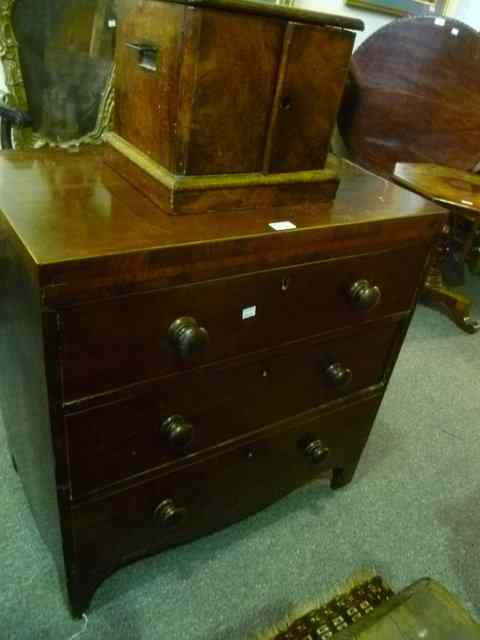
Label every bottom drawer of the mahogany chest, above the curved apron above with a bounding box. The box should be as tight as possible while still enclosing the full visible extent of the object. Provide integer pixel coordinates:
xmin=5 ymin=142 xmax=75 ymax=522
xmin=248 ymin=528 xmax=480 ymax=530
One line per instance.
xmin=70 ymin=397 xmax=380 ymax=575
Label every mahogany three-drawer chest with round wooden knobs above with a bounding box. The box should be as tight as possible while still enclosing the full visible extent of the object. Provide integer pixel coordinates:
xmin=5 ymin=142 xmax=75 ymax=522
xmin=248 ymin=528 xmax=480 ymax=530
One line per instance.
xmin=0 ymin=151 xmax=444 ymax=615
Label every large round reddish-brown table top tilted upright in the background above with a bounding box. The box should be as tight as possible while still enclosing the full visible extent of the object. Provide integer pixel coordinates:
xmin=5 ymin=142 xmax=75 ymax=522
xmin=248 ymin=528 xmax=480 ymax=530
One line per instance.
xmin=339 ymin=17 xmax=480 ymax=176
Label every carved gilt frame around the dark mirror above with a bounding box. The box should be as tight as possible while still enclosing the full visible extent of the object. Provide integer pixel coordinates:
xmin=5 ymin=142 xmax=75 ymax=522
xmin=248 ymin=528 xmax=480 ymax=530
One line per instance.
xmin=0 ymin=0 xmax=115 ymax=149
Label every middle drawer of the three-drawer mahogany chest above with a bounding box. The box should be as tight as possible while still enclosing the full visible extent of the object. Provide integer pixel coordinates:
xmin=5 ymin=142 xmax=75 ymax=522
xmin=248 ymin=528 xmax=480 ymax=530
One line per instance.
xmin=66 ymin=323 xmax=402 ymax=499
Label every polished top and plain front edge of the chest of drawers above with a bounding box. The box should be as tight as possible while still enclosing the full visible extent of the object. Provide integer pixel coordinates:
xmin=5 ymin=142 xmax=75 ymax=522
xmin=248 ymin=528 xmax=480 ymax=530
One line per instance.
xmin=0 ymin=151 xmax=443 ymax=305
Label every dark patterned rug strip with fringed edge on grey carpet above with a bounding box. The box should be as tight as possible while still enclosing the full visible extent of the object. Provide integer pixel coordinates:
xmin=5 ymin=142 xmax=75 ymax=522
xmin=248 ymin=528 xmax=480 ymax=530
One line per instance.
xmin=259 ymin=575 xmax=393 ymax=640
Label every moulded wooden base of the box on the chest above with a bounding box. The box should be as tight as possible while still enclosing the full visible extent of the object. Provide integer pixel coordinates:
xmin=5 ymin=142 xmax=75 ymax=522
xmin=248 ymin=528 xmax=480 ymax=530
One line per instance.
xmin=105 ymin=132 xmax=339 ymax=215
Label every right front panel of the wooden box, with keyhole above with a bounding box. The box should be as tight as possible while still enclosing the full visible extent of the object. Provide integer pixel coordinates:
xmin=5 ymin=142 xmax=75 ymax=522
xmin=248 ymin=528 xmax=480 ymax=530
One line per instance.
xmin=263 ymin=24 xmax=354 ymax=173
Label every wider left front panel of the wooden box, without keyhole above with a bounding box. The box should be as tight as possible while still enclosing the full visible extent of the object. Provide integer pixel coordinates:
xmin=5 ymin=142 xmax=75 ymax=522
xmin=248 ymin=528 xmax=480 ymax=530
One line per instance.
xmin=174 ymin=10 xmax=284 ymax=175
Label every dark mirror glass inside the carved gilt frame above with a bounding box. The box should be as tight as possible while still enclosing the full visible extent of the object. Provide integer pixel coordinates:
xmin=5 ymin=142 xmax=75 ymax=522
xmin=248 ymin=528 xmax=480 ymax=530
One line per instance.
xmin=12 ymin=0 xmax=116 ymax=143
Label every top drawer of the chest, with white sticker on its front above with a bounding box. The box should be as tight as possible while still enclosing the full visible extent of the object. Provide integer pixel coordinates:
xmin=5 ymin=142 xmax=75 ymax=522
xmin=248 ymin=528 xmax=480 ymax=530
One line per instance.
xmin=62 ymin=246 xmax=426 ymax=401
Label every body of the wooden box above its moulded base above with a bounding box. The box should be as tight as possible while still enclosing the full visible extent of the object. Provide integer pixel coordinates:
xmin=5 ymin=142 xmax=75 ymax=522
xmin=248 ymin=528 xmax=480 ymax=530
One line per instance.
xmin=115 ymin=0 xmax=358 ymax=176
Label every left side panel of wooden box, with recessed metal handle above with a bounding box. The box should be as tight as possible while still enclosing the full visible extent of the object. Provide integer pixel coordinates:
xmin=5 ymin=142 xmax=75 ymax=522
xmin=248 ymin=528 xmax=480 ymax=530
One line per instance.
xmin=115 ymin=0 xmax=185 ymax=171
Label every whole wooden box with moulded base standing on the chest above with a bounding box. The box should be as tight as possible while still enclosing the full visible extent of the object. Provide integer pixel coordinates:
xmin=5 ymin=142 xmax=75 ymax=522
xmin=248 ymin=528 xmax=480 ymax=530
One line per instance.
xmin=105 ymin=0 xmax=362 ymax=214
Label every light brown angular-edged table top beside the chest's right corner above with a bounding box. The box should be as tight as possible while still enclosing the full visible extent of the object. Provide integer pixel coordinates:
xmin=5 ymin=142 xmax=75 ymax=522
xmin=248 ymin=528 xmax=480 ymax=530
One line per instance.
xmin=393 ymin=163 xmax=480 ymax=214
